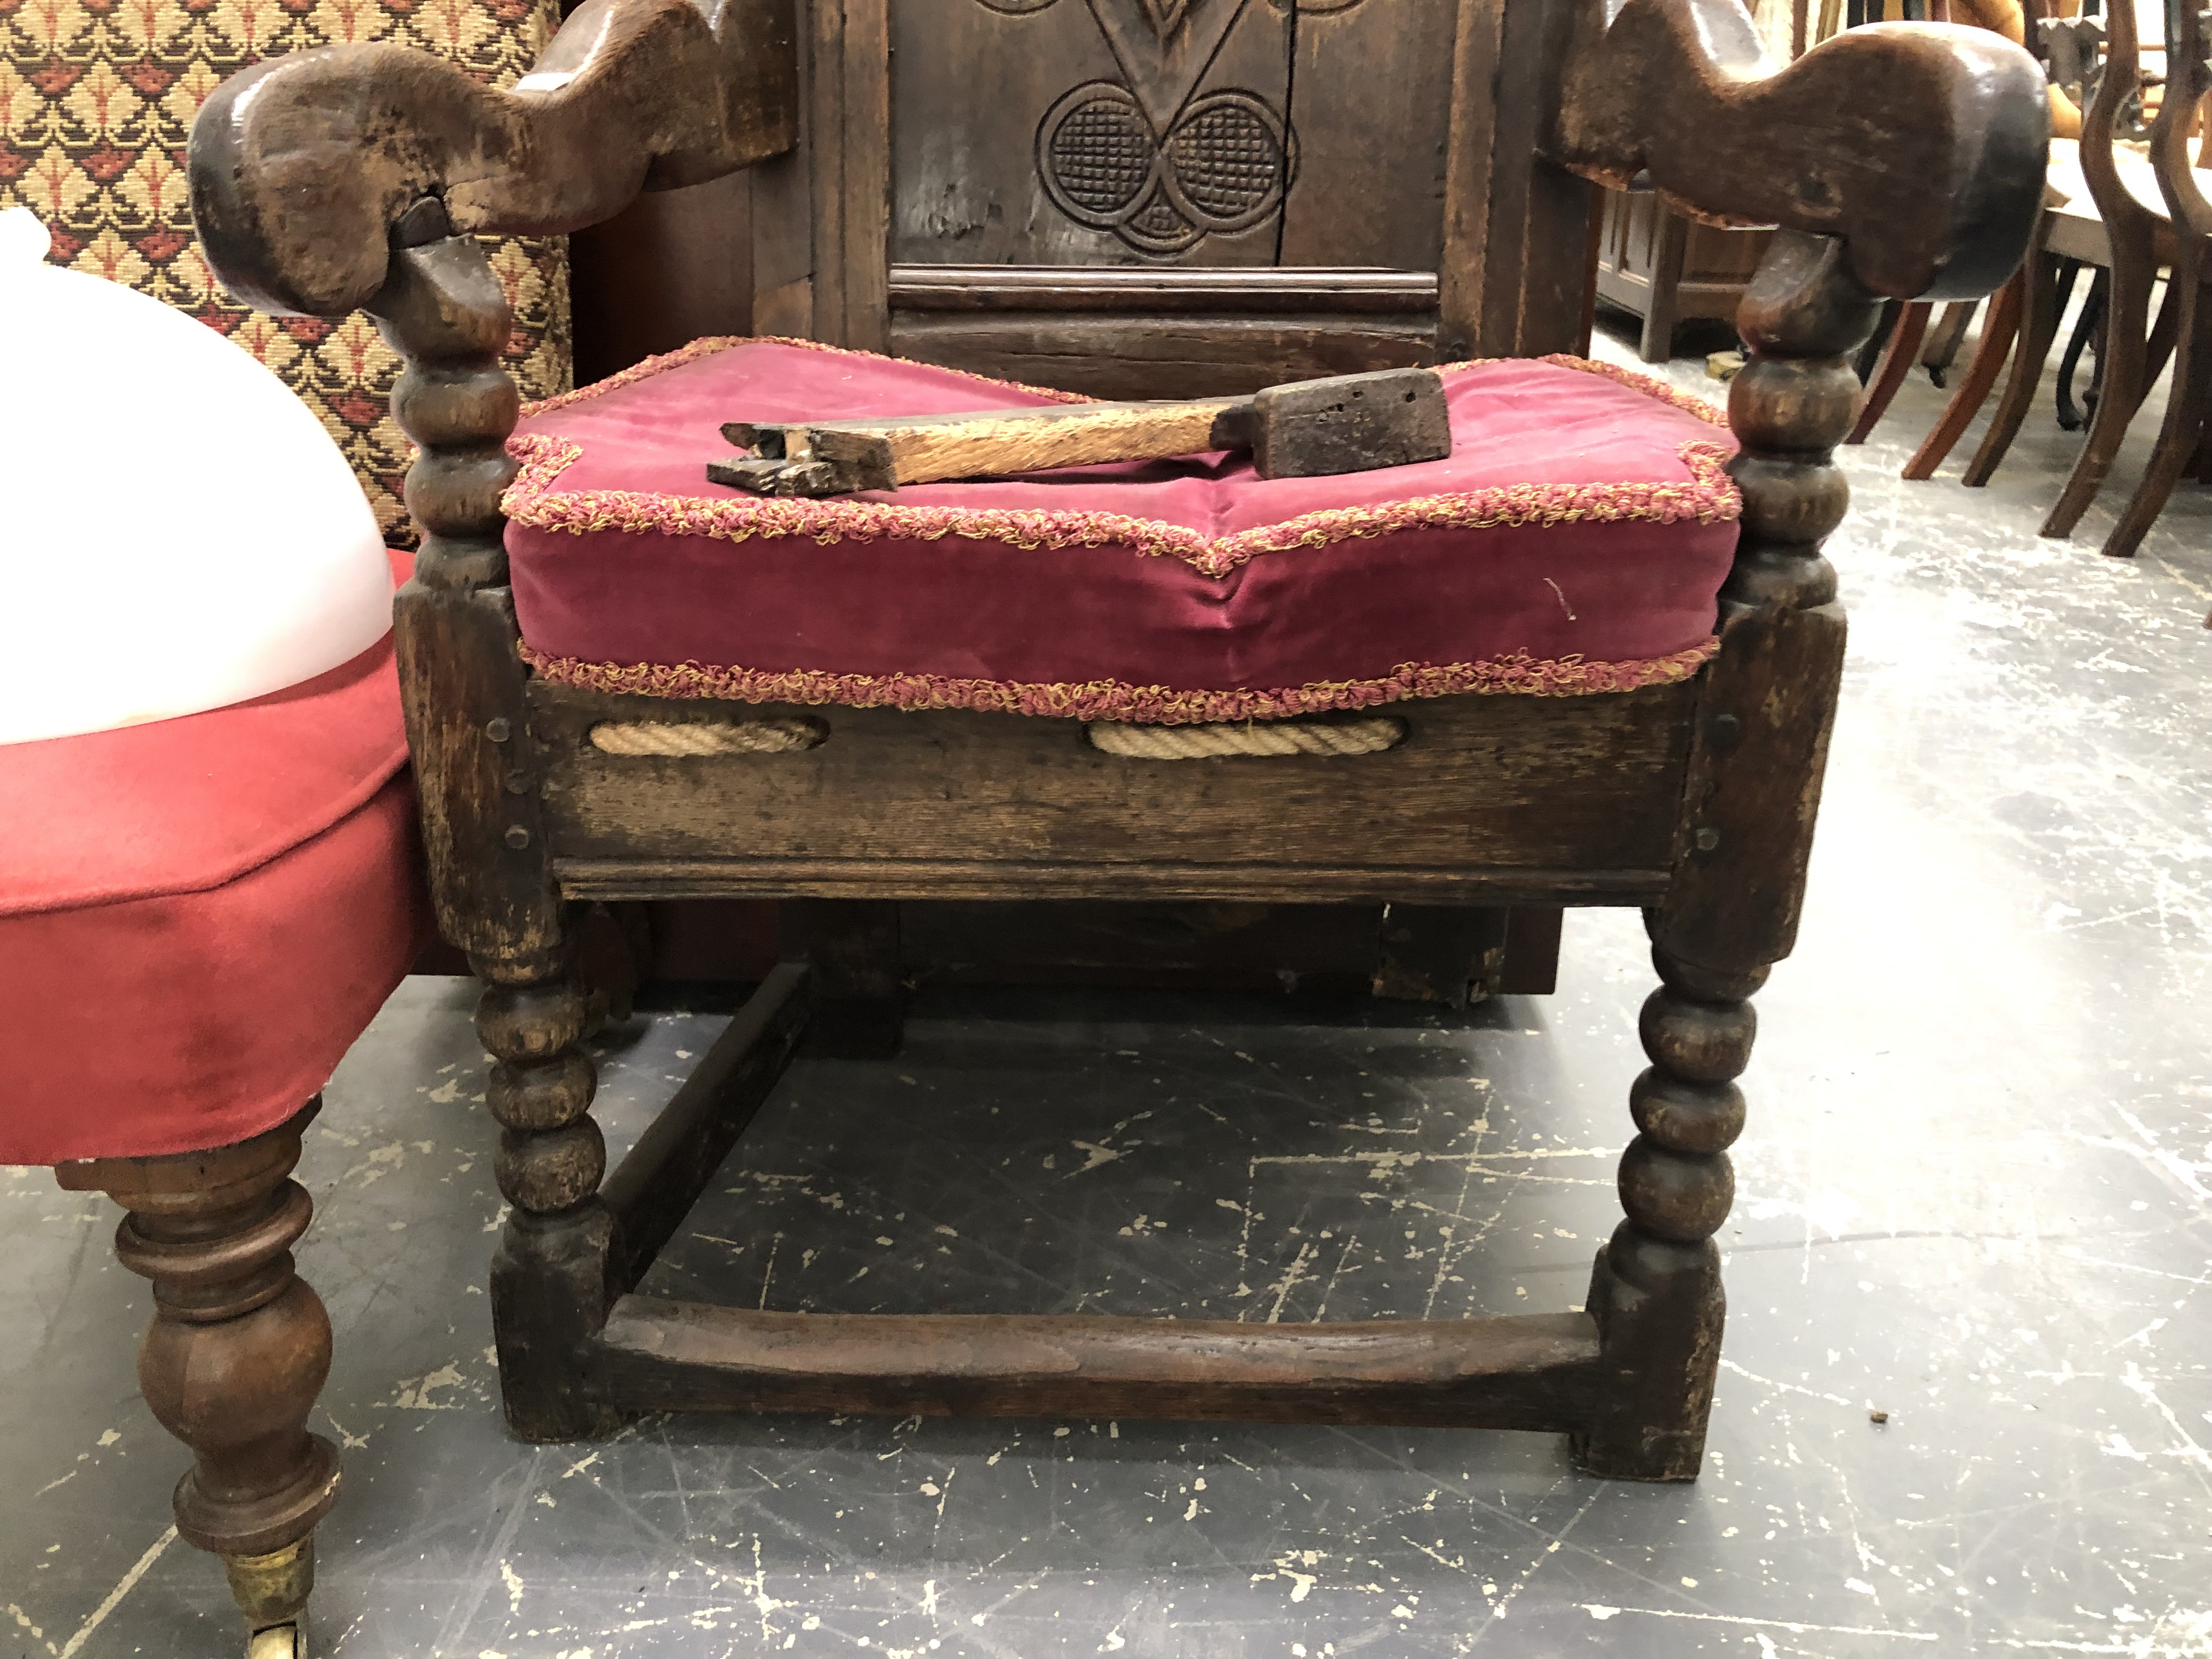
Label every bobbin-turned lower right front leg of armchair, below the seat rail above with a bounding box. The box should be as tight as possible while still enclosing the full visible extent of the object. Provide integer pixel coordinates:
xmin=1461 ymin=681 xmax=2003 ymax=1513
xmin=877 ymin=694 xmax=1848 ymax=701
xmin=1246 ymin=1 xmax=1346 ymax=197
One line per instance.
xmin=1573 ymin=951 xmax=1768 ymax=1480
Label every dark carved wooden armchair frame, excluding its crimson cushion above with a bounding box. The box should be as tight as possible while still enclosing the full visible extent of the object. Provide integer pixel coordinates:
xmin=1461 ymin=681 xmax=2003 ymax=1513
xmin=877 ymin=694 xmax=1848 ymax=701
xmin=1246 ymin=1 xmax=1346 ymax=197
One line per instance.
xmin=193 ymin=0 xmax=2049 ymax=1480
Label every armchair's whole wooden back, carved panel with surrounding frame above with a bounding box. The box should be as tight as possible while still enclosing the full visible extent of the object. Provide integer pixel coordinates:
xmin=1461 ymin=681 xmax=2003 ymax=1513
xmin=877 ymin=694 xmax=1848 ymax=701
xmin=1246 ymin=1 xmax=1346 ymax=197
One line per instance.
xmin=754 ymin=0 xmax=1588 ymax=396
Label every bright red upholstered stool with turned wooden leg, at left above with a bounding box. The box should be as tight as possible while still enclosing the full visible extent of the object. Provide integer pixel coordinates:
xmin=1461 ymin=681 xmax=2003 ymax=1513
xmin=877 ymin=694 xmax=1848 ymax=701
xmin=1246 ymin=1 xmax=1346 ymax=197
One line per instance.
xmin=0 ymin=562 xmax=429 ymax=1659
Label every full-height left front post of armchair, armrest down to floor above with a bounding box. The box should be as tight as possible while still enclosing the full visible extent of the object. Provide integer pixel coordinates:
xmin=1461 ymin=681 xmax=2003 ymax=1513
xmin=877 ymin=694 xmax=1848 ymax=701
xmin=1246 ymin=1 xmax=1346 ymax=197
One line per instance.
xmin=367 ymin=197 xmax=615 ymax=1440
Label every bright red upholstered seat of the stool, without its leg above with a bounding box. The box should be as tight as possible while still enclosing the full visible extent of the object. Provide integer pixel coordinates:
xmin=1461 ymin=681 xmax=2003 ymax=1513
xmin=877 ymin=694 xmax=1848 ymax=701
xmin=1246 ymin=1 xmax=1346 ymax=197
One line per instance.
xmin=0 ymin=555 xmax=429 ymax=1164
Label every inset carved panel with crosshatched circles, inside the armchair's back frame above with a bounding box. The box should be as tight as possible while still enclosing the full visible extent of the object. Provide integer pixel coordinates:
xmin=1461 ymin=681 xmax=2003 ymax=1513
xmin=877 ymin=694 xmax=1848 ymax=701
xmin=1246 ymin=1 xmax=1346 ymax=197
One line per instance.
xmin=891 ymin=0 xmax=1458 ymax=270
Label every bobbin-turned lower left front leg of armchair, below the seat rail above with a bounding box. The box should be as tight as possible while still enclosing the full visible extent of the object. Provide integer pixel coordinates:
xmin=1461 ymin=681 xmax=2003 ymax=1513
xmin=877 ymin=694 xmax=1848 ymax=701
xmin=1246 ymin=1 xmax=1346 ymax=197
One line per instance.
xmin=471 ymin=953 xmax=619 ymax=1442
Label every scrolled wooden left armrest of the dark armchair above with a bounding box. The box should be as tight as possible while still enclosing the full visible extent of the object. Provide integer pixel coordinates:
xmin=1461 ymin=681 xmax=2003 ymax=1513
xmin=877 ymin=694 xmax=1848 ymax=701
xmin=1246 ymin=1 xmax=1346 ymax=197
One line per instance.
xmin=188 ymin=0 xmax=799 ymax=317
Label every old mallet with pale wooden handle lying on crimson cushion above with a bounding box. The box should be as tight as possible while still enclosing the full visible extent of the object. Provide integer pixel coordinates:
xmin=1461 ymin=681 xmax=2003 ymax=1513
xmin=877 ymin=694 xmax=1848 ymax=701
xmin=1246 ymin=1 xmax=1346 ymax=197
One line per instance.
xmin=706 ymin=369 xmax=1451 ymax=495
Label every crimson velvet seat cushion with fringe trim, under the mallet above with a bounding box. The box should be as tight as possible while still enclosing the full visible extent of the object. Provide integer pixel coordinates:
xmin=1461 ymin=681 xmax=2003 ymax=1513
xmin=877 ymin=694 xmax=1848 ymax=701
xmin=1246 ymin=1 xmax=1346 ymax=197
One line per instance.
xmin=506 ymin=341 xmax=1739 ymax=721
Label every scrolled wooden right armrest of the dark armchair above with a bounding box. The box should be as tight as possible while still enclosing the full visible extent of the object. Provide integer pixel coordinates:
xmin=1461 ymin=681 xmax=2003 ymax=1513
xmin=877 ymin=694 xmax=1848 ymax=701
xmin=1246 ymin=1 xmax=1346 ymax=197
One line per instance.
xmin=1546 ymin=0 xmax=2051 ymax=298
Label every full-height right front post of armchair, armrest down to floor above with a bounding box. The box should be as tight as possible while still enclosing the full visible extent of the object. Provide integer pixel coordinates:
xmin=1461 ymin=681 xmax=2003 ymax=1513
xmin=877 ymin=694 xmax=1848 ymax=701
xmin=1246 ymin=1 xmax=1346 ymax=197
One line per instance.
xmin=1575 ymin=232 xmax=1878 ymax=1480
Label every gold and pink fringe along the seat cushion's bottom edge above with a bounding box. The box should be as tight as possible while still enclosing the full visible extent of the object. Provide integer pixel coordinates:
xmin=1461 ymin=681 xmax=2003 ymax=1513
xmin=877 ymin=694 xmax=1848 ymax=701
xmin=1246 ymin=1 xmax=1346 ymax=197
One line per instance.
xmin=522 ymin=639 xmax=1719 ymax=725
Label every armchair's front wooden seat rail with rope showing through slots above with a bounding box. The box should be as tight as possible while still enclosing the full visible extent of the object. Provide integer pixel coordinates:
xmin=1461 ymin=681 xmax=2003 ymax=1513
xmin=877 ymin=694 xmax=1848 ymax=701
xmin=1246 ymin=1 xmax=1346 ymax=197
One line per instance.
xmin=531 ymin=681 xmax=1695 ymax=876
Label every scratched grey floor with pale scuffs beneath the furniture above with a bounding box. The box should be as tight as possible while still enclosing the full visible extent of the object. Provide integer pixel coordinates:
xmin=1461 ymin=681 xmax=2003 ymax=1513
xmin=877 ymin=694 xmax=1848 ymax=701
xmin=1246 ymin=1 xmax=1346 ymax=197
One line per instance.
xmin=0 ymin=314 xmax=2212 ymax=1659
